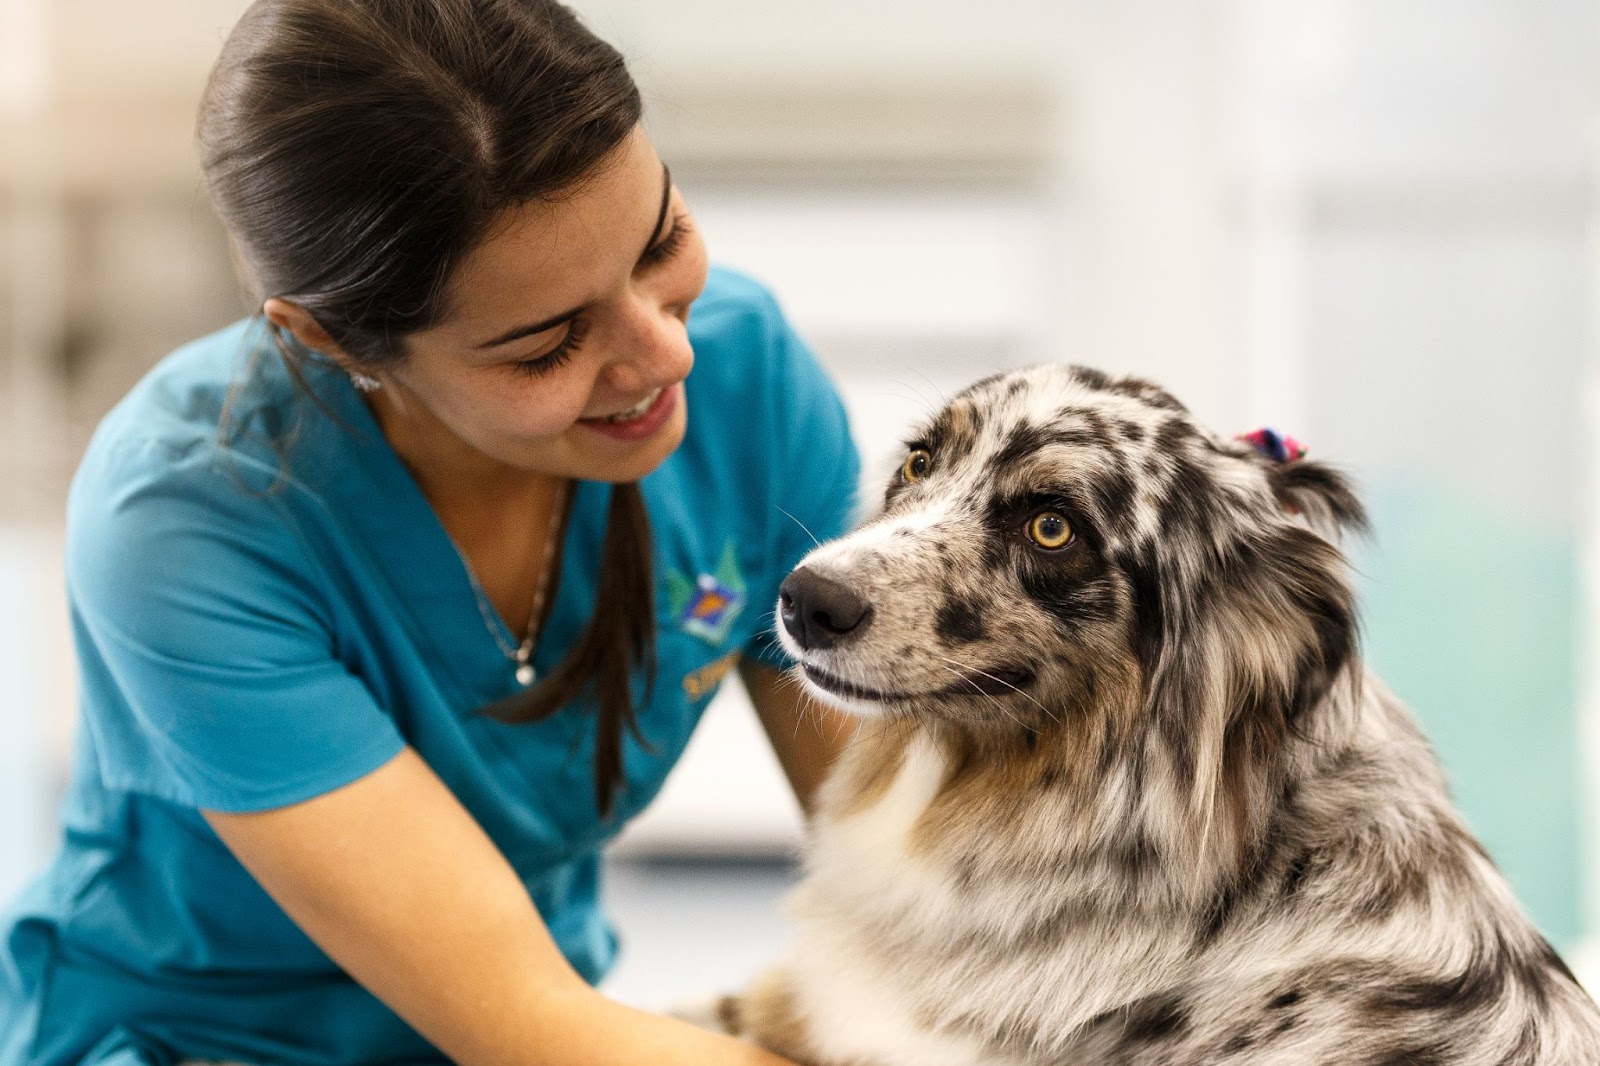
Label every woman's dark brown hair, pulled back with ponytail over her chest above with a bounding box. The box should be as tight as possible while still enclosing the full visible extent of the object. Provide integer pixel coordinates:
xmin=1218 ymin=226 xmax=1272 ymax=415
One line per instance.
xmin=198 ymin=0 xmax=654 ymax=813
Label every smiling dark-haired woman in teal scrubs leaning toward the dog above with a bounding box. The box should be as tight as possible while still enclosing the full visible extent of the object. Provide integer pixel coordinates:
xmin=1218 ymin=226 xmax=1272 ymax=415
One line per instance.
xmin=0 ymin=0 xmax=856 ymax=1066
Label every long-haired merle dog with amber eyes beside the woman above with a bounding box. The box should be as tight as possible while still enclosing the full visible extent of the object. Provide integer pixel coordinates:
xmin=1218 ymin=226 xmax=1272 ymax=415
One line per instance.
xmin=694 ymin=367 xmax=1600 ymax=1066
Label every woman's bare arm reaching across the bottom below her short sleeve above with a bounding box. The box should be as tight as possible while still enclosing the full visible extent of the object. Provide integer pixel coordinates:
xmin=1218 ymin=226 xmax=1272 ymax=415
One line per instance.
xmin=205 ymin=749 xmax=786 ymax=1066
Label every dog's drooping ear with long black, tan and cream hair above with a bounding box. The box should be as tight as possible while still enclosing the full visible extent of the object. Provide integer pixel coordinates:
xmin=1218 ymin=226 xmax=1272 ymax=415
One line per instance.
xmin=1136 ymin=521 xmax=1357 ymax=861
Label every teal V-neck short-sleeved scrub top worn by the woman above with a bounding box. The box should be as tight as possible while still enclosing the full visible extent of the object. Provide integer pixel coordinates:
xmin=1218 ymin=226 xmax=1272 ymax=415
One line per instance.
xmin=0 ymin=271 xmax=858 ymax=1066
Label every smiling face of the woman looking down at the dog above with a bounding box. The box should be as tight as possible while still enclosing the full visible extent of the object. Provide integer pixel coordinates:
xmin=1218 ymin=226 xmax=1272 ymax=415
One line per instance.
xmin=370 ymin=130 xmax=706 ymax=482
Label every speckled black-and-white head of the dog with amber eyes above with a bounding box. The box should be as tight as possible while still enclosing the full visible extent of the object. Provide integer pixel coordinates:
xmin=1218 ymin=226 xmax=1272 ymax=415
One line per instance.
xmin=779 ymin=367 xmax=1363 ymax=809
